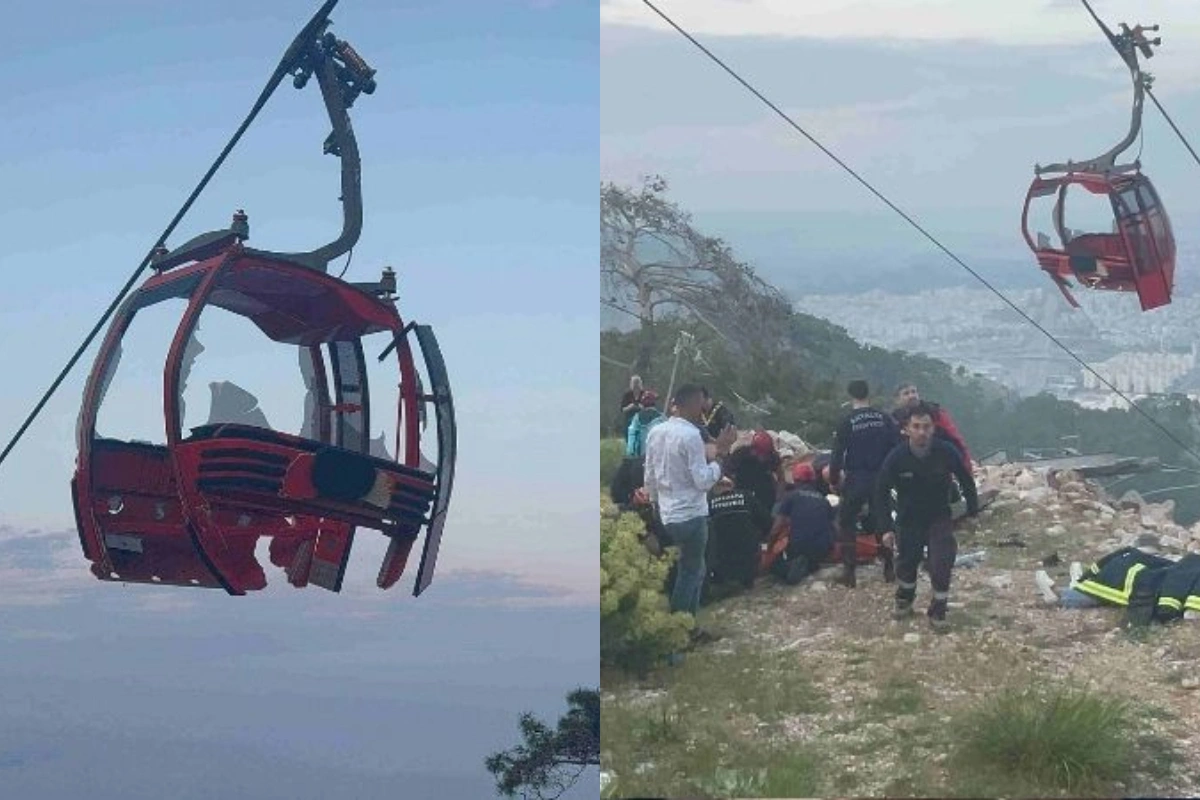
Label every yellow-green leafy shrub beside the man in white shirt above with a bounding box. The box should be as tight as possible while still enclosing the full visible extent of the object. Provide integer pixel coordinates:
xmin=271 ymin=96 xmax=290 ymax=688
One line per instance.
xmin=600 ymin=501 xmax=694 ymax=674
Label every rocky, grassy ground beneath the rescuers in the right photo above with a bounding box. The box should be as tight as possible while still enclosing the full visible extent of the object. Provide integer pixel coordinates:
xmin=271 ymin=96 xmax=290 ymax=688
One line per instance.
xmin=601 ymin=467 xmax=1200 ymax=798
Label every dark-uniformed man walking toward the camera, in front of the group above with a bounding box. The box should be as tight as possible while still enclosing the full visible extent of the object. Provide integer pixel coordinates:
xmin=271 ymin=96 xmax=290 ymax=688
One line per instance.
xmin=875 ymin=403 xmax=979 ymax=632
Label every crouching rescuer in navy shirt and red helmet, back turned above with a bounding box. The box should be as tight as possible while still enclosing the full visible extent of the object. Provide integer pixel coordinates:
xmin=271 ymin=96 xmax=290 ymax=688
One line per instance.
xmin=768 ymin=464 xmax=834 ymax=584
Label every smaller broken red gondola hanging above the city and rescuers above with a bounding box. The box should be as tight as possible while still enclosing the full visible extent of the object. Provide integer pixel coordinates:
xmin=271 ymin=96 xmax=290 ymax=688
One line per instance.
xmin=1021 ymin=6 xmax=1175 ymax=311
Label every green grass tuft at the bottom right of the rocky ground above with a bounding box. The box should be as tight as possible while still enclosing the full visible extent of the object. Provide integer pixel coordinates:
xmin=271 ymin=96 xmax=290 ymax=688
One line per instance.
xmin=950 ymin=688 xmax=1157 ymax=796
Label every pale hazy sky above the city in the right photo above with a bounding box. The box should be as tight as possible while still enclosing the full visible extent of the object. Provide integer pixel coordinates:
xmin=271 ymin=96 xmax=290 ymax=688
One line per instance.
xmin=601 ymin=0 xmax=1200 ymax=270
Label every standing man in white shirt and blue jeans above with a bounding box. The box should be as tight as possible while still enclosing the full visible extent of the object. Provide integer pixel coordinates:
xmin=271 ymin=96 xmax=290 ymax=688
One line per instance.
xmin=646 ymin=384 xmax=737 ymax=616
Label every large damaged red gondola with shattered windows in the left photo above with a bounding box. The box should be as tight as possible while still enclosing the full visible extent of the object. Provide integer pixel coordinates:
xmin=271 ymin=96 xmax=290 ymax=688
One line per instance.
xmin=71 ymin=2 xmax=456 ymax=595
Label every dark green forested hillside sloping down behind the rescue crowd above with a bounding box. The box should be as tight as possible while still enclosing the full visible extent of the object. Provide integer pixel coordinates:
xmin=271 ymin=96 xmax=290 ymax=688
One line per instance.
xmin=600 ymin=179 xmax=1200 ymax=524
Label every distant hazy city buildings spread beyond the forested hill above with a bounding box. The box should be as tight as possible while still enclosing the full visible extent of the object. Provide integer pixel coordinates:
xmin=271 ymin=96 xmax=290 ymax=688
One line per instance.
xmin=796 ymin=244 xmax=1200 ymax=408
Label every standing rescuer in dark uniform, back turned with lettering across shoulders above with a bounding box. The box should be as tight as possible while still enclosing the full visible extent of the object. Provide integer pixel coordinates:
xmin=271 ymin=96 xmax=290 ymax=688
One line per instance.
xmin=829 ymin=380 xmax=901 ymax=589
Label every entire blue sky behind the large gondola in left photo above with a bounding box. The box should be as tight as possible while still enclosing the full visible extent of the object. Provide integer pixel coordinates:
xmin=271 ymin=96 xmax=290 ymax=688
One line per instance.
xmin=0 ymin=0 xmax=599 ymax=796
